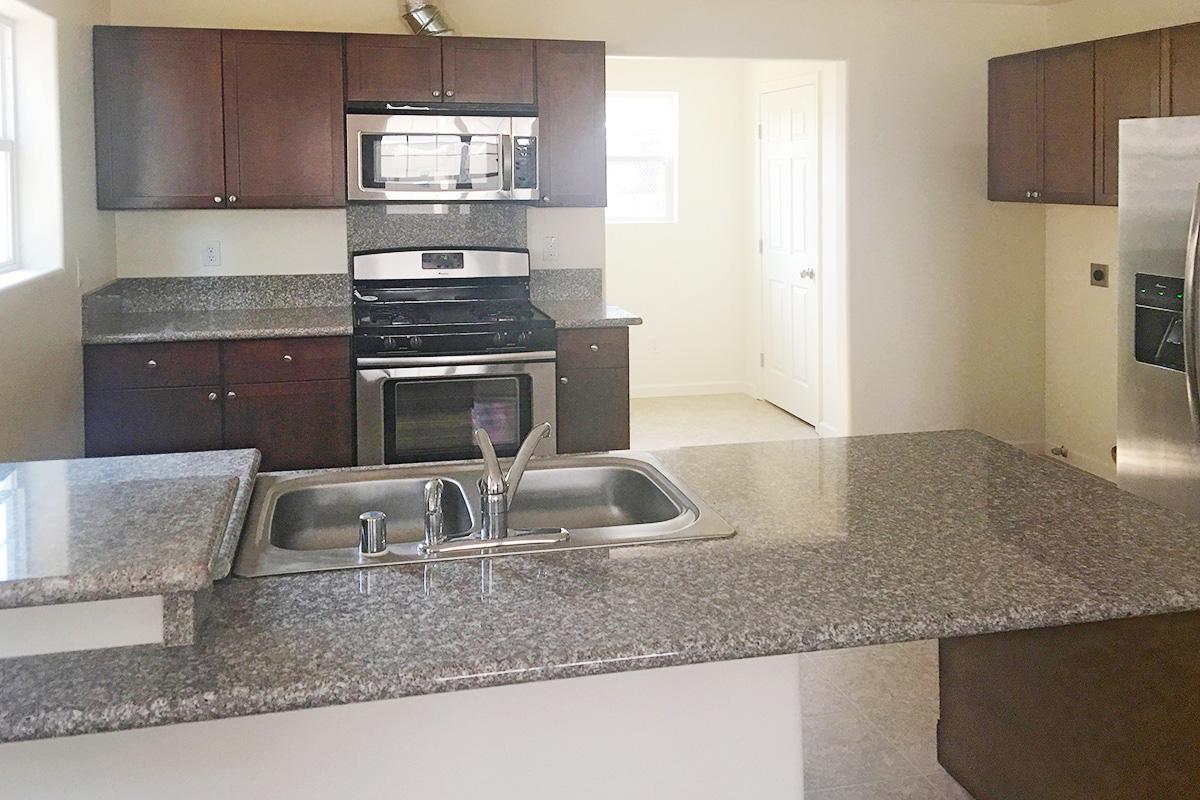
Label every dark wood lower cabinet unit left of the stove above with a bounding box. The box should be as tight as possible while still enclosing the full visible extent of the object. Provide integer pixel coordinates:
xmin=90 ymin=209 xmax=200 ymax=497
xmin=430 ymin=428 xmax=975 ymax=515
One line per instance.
xmin=84 ymin=337 xmax=354 ymax=470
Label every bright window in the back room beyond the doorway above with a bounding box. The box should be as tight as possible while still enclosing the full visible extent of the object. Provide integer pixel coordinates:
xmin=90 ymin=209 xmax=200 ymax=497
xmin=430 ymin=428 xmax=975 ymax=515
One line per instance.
xmin=606 ymin=91 xmax=679 ymax=222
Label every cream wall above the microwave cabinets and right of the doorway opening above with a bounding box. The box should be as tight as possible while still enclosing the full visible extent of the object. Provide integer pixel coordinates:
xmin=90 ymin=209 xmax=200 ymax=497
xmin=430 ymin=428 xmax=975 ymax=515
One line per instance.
xmin=113 ymin=0 xmax=1045 ymax=441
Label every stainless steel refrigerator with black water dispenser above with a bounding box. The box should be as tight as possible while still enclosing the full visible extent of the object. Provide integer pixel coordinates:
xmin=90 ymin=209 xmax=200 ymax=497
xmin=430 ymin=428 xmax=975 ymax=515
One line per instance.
xmin=1117 ymin=116 xmax=1200 ymax=517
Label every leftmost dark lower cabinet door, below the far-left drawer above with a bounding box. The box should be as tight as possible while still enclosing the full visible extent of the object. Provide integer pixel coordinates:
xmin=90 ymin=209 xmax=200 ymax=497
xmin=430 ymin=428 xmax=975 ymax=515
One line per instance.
xmin=84 ymin=386 xmax=221 ymax=457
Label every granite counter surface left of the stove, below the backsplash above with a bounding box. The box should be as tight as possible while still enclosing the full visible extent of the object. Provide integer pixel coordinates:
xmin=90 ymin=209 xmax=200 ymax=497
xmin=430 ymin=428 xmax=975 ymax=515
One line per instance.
xmin=83 ymin=305 xmax=354 ymax=344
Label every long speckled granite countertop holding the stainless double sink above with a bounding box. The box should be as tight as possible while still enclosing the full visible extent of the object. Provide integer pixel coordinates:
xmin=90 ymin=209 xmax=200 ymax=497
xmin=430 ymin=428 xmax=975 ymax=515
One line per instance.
xmin=0 ymin=432 xmax=1200 ymax=741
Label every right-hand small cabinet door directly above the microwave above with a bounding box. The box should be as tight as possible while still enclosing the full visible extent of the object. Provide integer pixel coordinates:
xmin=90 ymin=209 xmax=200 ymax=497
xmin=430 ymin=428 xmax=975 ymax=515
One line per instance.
xmin=440 ymin=36 xmax=536 ymax=106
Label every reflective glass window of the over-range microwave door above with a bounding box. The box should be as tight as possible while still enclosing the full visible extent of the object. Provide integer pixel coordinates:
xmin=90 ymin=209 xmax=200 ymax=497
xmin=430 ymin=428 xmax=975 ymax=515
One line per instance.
xmin=362 ymin=133 xmax=502 ymax=192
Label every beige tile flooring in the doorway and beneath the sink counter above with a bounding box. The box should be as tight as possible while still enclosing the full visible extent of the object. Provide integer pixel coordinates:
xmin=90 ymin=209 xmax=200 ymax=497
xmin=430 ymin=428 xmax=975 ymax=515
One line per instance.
xmin=630 ymin=395 xmax=971 ymax=800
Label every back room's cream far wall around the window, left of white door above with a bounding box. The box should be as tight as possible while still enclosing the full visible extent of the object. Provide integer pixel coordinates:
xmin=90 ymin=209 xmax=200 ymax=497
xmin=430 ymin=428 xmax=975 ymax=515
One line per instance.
xmin=605 ymin=58 xmax=752 ymax=397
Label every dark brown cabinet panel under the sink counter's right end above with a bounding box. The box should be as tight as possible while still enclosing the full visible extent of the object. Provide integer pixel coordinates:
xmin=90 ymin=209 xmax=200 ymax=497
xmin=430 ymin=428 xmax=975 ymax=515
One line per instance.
xmin=937 ymin=613 xmax=1200 ymax=800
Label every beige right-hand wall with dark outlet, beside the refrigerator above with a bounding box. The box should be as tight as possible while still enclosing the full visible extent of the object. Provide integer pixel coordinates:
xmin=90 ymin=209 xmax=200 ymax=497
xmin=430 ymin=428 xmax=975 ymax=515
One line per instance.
xmin=1045 ymin=0 xmax=1200 ymax=479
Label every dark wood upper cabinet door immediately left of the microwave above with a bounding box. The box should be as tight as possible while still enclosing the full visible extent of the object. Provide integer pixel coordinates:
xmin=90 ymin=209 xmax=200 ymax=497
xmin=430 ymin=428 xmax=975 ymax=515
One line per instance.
xmin=222 ymin=31 xmax=346 ymax=209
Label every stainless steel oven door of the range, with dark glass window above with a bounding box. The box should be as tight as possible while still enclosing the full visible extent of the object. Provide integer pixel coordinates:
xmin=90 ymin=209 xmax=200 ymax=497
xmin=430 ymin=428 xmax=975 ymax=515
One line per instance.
xmin=358 ymin=351 xmax=557 ymax=465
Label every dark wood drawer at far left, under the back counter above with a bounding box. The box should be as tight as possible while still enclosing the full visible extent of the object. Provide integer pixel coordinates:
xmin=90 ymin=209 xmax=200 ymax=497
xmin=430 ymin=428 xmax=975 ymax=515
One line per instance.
xmin=83 ymin=342 xmax=221 ymax=389
